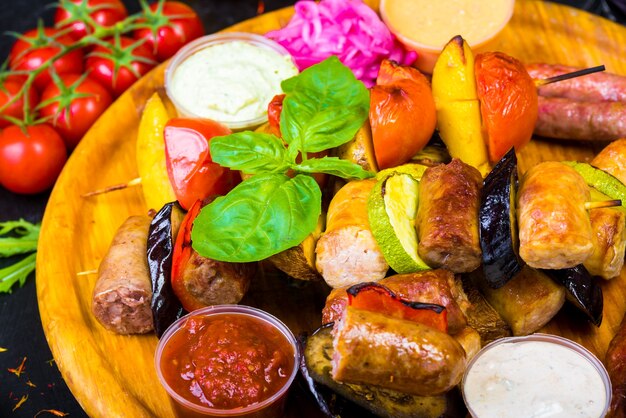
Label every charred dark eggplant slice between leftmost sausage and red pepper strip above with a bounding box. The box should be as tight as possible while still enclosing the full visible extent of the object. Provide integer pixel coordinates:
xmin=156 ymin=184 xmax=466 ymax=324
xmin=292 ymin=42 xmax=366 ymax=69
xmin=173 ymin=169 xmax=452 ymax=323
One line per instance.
xmin=147 ymin=202 xmax=185 ymax=338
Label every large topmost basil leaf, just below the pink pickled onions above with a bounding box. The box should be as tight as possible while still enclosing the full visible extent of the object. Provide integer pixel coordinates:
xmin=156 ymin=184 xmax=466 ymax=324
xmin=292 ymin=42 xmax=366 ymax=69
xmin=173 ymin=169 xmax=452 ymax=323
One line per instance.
xmin=280 ymin=56 xmax=369 ymax=152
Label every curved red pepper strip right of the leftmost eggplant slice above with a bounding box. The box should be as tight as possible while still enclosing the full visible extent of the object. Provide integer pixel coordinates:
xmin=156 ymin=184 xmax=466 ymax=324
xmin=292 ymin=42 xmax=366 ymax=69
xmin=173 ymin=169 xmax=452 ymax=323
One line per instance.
xmin=172 ymin=200 xmax=205 ymax=312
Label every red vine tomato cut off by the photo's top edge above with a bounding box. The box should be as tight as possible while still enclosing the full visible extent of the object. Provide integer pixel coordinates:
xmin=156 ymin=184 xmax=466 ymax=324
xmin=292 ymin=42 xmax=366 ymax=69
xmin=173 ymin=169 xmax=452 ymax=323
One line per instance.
xmin=54 ymin=0 xmax=128 ymax=40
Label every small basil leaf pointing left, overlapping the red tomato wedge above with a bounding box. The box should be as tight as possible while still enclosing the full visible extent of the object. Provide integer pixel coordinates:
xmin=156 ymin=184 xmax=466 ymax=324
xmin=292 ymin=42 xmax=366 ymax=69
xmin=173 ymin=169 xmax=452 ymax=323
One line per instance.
xmin=210 ymin=131 xmax=289 ymax=174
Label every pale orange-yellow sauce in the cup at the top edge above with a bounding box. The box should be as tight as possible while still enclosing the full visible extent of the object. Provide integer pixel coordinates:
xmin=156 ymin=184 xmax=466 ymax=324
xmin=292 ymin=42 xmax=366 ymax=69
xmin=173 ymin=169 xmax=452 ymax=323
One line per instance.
xmin=380 ymin=0 xmax=514 ymax=49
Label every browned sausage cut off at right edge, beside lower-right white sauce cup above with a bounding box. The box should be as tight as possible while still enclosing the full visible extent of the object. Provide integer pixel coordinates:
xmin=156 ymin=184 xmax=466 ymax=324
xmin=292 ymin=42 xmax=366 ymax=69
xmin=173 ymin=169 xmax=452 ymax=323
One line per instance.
xmin=604 ymin=316 xmax=626 ymax=418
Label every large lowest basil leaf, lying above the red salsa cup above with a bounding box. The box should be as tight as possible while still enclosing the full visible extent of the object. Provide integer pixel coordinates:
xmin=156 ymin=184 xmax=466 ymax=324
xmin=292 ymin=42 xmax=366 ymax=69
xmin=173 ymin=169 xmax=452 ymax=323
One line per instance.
xmin=191 ymin=174 xmax=322 ymax=263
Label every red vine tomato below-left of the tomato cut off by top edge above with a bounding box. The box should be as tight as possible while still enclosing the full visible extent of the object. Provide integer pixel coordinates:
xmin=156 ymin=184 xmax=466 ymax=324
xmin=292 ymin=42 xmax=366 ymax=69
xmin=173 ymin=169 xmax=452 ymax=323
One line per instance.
xmin=9 ymin=28 xmax=83 ymax=90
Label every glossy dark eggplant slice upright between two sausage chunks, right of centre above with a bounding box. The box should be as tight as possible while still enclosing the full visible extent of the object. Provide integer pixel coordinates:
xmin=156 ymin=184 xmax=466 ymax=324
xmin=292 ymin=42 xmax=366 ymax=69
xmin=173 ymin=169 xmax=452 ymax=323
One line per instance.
xmin=478 ymin=148 xmax=523 ymax=289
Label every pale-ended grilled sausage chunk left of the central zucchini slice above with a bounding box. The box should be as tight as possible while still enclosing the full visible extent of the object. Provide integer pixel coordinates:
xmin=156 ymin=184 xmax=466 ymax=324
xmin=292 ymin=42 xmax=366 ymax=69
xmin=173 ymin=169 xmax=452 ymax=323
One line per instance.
xmin=315 ymin=179 xmax=389 ymax=287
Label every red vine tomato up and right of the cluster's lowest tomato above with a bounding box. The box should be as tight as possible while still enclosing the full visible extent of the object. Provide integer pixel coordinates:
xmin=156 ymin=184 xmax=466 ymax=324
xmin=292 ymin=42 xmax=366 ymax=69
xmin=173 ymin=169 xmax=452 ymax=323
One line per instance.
xmin=40 ymin=74 xmax=113 ymax=150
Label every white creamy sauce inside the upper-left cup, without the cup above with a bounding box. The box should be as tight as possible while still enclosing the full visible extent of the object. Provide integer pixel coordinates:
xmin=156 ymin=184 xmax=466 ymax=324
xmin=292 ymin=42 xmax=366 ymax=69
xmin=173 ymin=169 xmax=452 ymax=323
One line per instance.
xmin=171 ymin=41 xmax=298 ymax=122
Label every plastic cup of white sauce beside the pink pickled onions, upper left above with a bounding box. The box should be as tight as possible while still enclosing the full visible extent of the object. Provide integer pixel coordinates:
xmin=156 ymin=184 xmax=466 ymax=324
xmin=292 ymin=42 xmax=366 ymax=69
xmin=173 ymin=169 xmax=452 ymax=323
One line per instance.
xmin=165 ymin=32 xmax=298 ymax=130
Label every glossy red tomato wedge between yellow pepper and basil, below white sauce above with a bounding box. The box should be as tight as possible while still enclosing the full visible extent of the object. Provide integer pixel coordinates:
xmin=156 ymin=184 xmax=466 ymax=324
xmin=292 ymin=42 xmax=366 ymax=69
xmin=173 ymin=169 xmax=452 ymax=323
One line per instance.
xmin=164 ymin=118 xmax=241 ymax=210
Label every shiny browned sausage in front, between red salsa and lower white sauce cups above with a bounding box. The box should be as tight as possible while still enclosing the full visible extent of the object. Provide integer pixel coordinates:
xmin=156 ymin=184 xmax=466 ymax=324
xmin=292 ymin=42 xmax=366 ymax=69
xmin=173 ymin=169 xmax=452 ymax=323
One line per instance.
xmin=332 ymin=306 xmax=466 ymax=396
